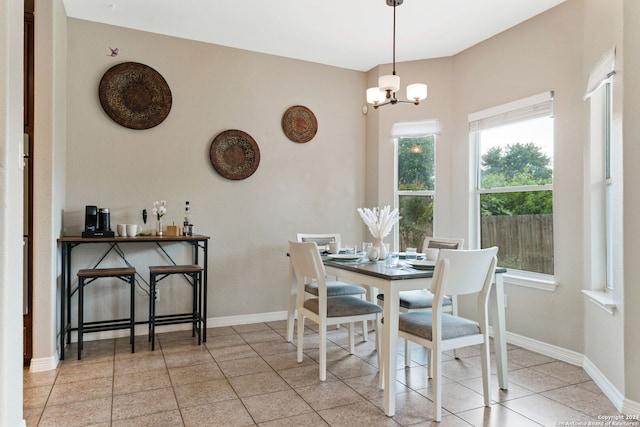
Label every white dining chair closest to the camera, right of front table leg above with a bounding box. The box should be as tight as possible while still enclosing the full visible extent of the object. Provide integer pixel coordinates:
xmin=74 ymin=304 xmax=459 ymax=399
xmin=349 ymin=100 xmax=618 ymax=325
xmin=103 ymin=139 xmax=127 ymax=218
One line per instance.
xmin=398 ymin=247 xmax=498 ymax=422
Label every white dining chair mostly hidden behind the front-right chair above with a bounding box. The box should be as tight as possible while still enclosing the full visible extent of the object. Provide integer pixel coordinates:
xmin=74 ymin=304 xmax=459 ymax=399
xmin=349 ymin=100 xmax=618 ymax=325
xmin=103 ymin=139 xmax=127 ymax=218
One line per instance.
xmin=377 ymin=236 xmax=464 ymax=370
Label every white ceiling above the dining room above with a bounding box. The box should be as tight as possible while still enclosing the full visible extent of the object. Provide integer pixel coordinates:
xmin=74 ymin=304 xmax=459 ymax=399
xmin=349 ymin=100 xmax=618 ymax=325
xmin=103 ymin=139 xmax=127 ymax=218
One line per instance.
xmin=63 ymin=0 xmax=564 ymax=71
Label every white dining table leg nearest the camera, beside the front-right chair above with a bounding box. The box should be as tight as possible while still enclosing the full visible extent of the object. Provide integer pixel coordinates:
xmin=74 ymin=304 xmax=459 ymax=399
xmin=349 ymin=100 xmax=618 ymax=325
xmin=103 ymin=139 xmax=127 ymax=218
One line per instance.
xmin=381 ymin=289 xmax=400 ymax=417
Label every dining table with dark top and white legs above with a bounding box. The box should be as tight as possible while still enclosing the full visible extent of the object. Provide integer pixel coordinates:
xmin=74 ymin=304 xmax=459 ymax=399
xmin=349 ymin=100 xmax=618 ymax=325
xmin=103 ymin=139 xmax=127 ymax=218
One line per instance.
xmin=302 ymin=254 xmax=509 ymax=417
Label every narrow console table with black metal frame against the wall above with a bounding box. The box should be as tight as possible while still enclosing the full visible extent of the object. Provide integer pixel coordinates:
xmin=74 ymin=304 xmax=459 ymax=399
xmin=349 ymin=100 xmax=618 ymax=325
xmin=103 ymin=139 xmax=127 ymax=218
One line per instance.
xmin=58 ymin=235 xmax=209 ymax=360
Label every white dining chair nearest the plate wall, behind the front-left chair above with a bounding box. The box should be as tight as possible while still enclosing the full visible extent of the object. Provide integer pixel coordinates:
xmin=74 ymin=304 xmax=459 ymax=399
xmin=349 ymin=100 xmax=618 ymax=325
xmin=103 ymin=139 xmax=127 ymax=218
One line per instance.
xmin=287 ymin=233 xmax=369 ymax=342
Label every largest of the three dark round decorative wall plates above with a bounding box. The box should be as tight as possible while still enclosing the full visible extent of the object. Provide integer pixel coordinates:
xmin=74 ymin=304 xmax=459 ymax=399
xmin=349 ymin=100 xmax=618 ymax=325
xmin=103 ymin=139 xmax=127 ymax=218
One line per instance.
xmin=98 ymin=62 xmax=172 ymax=129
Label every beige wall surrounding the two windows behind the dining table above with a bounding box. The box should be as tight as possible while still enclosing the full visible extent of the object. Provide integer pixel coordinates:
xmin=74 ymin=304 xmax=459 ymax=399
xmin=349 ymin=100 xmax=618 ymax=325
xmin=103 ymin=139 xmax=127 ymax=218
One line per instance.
xmin=368 ymin=1 xmax=585 ymax=352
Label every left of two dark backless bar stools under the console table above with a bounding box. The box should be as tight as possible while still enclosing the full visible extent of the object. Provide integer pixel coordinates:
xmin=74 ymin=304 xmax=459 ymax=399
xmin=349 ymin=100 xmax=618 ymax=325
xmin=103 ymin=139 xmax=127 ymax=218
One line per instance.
xmin=78 ymin=267 xmax=136 ymax=360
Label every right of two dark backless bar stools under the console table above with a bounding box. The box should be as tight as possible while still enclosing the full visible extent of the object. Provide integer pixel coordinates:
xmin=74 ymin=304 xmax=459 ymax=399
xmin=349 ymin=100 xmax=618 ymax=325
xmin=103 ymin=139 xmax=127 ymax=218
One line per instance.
xmin=149 ymin=265 xmax=204 ymax=350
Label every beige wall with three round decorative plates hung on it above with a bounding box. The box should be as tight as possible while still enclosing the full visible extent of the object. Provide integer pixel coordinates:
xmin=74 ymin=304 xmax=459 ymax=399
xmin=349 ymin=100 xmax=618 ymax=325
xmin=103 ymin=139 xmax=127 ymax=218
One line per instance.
xmin=64 ymin=19 xmax=365 ymax=319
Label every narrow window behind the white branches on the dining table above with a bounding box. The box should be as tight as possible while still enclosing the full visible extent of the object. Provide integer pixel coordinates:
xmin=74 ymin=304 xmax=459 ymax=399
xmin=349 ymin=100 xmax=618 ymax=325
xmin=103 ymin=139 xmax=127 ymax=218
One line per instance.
xmin=392 ymin=121 xmax=438 ymax=251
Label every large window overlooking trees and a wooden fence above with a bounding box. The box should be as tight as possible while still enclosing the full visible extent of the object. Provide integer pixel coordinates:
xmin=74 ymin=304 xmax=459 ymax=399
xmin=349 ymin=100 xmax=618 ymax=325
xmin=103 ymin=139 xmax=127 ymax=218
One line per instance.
xmin=470 ymin=92 xmax=554 ymax=275
